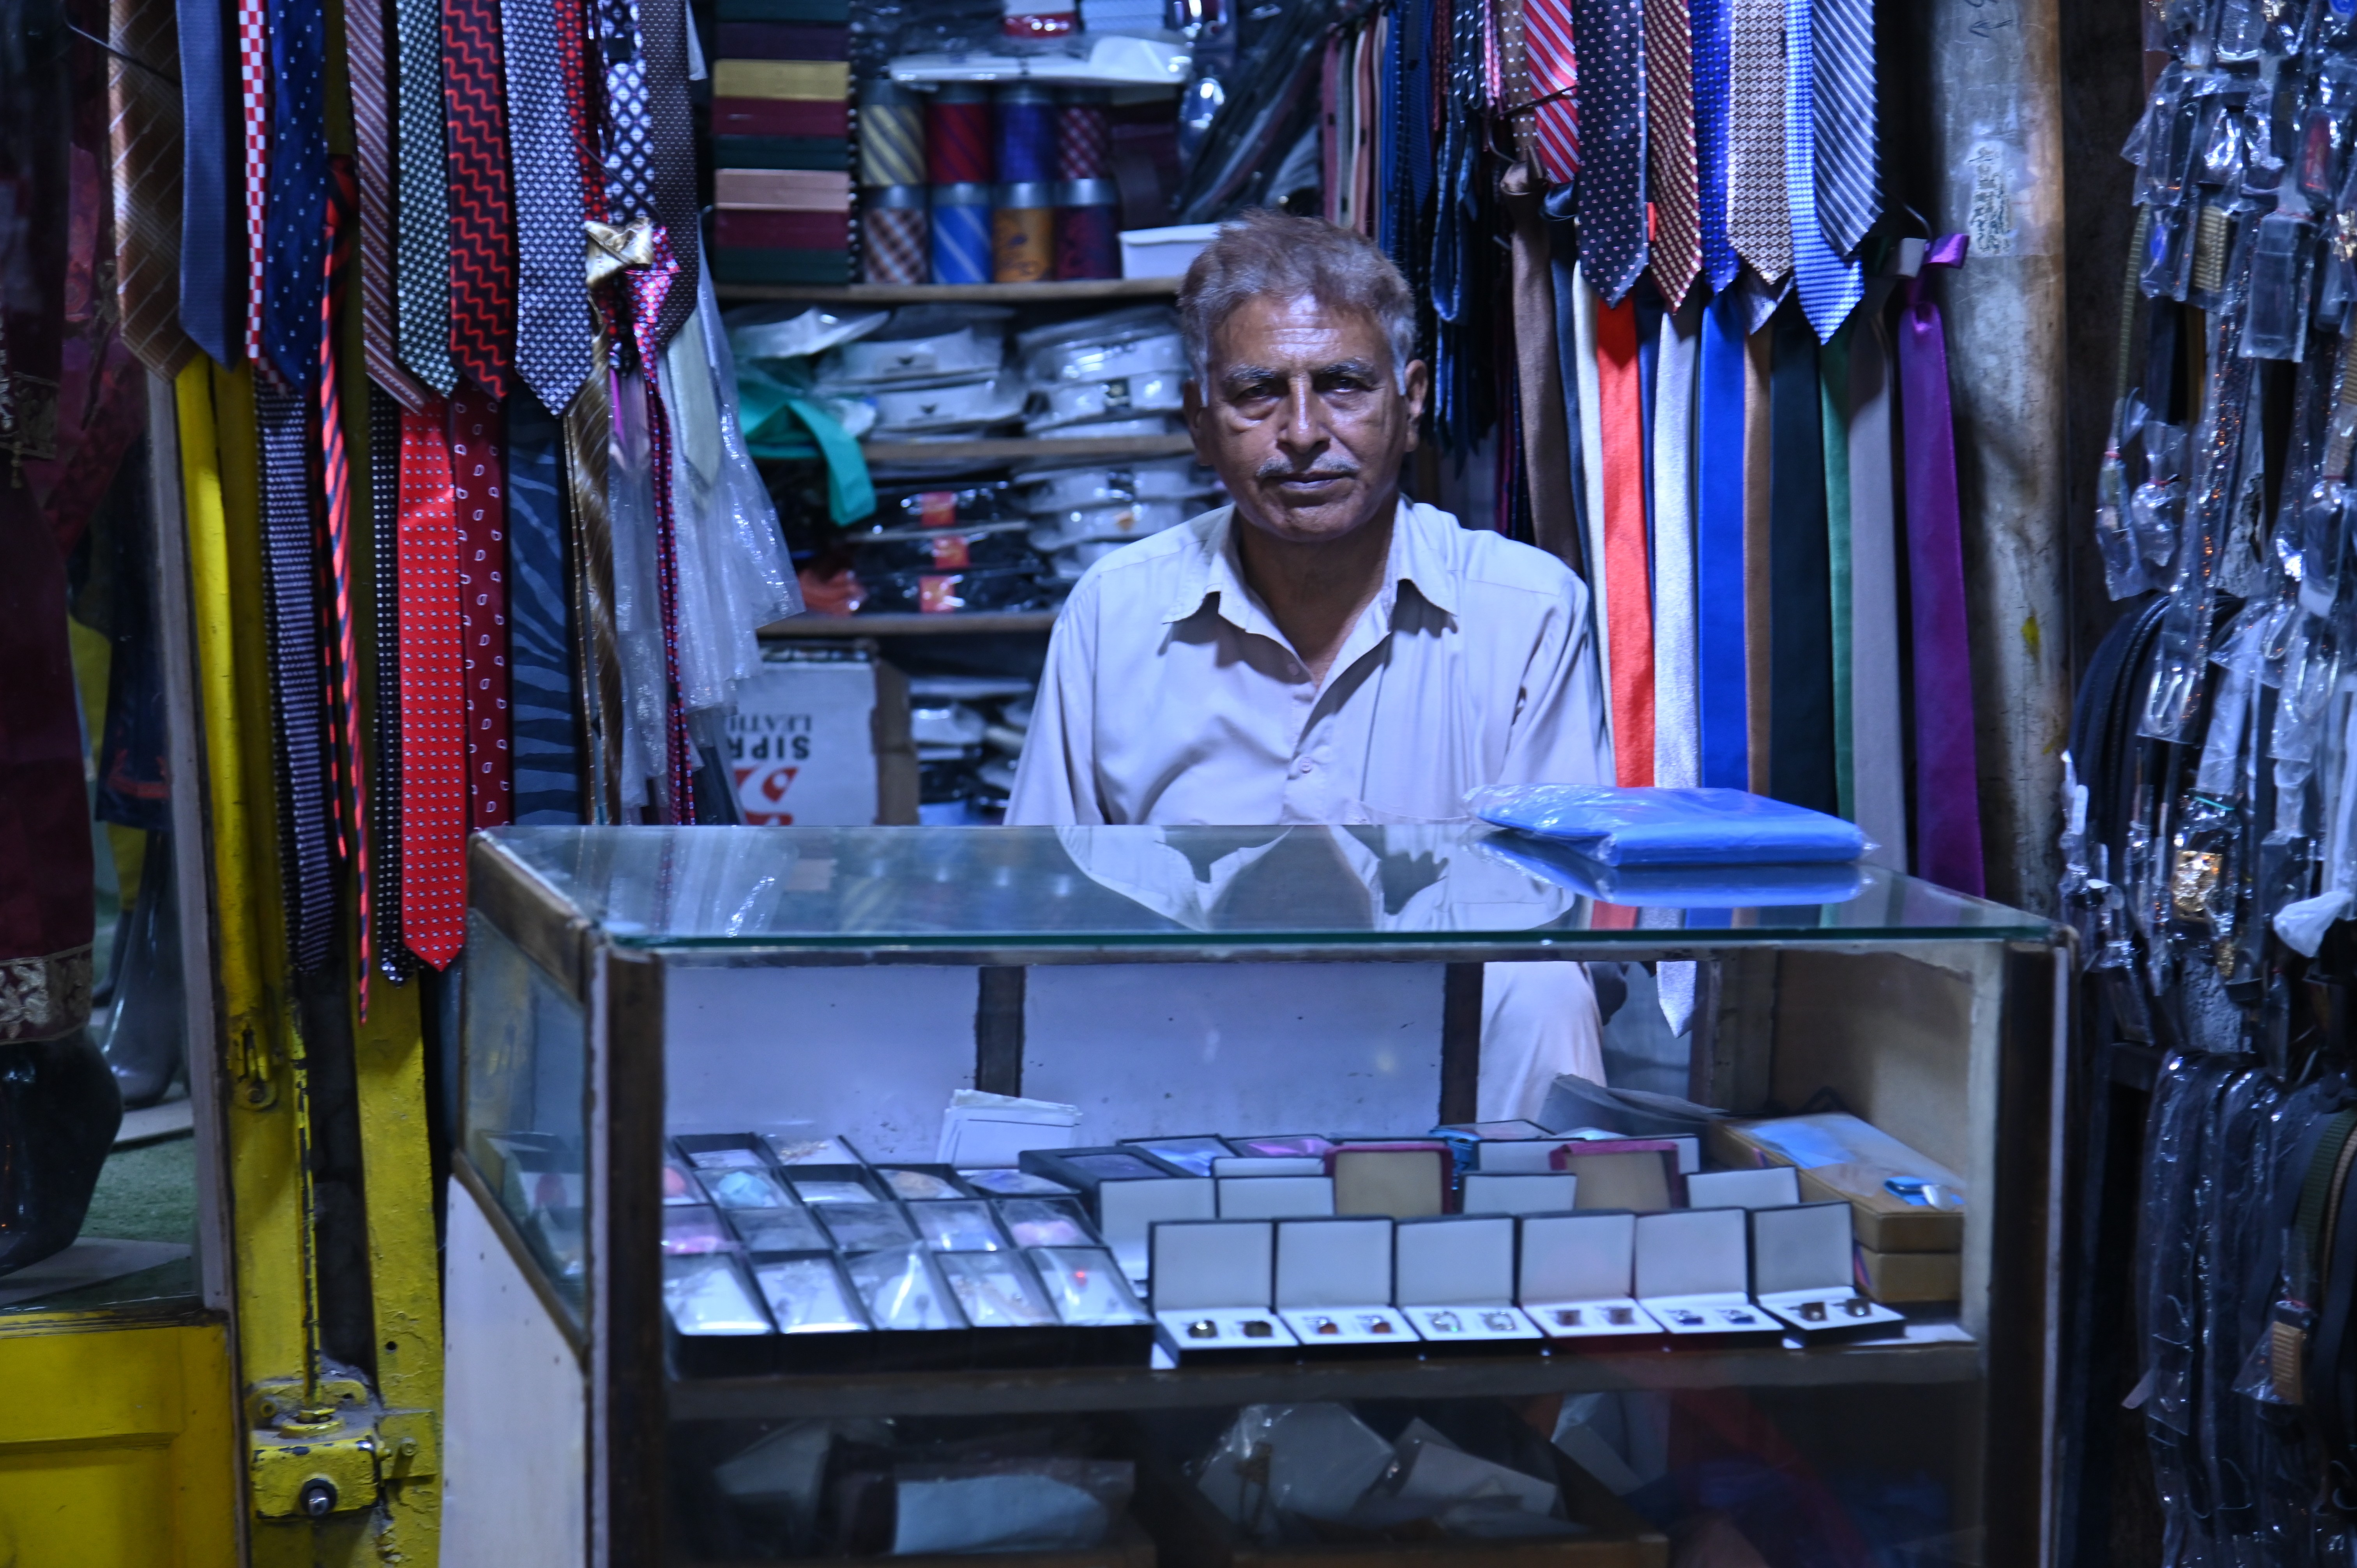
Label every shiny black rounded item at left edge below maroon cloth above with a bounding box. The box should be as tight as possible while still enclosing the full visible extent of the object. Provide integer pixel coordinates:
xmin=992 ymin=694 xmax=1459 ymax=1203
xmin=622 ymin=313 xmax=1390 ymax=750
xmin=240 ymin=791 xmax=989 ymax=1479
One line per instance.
xmin=0 ymin=1033 xmax=122 ymax=1276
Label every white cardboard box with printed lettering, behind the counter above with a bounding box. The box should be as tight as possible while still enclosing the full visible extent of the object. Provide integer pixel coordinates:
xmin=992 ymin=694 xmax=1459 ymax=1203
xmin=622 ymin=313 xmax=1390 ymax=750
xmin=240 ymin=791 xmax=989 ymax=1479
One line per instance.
xmin=728 ymin=644 xmax=917 ymax=828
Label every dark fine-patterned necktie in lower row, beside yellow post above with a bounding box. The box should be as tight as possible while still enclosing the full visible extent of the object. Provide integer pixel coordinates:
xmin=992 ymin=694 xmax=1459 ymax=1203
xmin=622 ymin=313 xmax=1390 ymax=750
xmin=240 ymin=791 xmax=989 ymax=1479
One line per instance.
xmin=254 ymin=380 xmax=337 ymax=971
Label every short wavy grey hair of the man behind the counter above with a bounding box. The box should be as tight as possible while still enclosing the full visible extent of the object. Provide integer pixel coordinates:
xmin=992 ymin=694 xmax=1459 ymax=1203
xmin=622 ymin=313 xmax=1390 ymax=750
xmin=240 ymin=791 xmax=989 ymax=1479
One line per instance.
xmin=1178 ymin=207 xmax=1417 ymax=389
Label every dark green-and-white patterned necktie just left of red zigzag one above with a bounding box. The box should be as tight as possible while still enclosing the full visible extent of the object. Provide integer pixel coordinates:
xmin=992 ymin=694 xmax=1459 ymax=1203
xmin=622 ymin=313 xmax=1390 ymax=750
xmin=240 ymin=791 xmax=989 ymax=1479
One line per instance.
xmin=394 ymin=0 xmax=457 ymax=391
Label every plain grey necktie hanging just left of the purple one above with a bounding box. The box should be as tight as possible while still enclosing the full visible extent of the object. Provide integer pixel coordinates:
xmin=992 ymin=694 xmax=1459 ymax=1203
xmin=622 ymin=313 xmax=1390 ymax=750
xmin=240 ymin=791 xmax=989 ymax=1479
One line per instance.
xmin=1846 ymin=278 xmax=1907 ymax=870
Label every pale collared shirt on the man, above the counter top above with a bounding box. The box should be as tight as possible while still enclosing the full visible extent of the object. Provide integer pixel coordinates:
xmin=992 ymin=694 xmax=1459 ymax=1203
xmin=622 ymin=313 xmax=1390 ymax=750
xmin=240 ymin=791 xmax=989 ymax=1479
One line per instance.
xmin=1006 ymin=502 xmax=1612 ymax=825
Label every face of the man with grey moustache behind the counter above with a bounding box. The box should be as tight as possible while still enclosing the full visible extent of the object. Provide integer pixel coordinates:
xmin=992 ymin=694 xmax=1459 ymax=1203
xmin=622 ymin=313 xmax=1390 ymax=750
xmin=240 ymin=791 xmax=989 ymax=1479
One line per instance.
xmin=1186 ymin=299 xmax=1424 ymax=545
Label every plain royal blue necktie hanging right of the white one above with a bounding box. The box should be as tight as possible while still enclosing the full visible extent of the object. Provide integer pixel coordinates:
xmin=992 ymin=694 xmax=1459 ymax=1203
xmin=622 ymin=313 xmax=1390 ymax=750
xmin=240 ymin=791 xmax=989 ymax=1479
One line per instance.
xmin=1695 ymin=289 xmax=1751 ymax=790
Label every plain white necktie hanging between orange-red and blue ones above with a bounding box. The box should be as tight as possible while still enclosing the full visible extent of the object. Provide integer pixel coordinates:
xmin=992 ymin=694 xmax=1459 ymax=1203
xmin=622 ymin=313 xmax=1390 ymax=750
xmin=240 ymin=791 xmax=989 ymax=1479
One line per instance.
xmin=1650 ymin=302 xmax=1702 ymax=790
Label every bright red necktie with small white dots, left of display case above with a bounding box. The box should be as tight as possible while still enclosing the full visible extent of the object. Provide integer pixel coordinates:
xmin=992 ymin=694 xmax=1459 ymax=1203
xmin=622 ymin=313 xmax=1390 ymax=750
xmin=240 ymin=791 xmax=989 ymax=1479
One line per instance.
xmin=401 ymin=406 xmax=467 ymax=969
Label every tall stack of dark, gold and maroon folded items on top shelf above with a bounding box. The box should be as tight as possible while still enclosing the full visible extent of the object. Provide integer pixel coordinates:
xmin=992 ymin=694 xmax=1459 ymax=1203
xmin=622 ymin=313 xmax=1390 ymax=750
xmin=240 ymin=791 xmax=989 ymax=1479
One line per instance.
xmin=712 ymin=0 xmax=851 ymax=283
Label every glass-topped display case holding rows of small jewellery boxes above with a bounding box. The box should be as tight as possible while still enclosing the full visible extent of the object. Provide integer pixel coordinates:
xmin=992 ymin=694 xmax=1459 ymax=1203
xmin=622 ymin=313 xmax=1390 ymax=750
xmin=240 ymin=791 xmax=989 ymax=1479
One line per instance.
xmin=445 ymin=825 xmax=2069 ymax=1568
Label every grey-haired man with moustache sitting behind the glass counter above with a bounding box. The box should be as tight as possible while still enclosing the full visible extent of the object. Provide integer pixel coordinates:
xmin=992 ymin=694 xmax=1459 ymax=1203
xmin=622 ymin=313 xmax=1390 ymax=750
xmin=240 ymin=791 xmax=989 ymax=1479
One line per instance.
xmin=1006 ymin=212 xmax=1610 ymax=1118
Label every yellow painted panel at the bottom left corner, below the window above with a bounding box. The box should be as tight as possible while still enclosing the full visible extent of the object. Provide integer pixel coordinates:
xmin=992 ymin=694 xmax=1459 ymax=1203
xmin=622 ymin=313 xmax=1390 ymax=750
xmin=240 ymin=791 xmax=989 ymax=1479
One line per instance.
xmin=0 ymin=1323 xmax=243 ymax=1568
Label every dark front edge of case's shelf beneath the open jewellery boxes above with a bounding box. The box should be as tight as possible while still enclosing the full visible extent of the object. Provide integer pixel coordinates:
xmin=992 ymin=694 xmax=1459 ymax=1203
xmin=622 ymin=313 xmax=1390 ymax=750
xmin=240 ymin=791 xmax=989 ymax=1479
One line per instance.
xmin=670 ymin=1344 xmax=1982 ymax=1420
